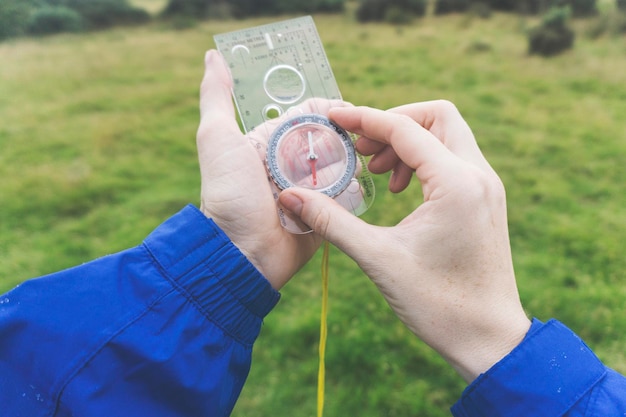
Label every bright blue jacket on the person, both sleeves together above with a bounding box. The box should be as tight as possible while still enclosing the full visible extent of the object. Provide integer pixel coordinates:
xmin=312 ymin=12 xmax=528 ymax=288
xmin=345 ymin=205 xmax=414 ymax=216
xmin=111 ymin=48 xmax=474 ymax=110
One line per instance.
xmin=0 ymin=206 xmax=626 ymax=417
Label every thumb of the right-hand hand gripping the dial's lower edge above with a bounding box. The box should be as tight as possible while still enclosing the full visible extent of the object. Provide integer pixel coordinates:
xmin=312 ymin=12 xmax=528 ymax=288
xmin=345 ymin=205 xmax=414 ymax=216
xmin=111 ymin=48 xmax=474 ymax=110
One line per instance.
xmin=279 ymin=187 xmax=374 ymax=262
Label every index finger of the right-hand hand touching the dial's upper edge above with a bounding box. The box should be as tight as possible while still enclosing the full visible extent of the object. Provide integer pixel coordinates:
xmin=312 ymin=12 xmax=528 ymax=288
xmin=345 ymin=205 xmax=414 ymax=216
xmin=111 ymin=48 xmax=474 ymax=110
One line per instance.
xmin=330 ymin=107 xmax=457 ymax=183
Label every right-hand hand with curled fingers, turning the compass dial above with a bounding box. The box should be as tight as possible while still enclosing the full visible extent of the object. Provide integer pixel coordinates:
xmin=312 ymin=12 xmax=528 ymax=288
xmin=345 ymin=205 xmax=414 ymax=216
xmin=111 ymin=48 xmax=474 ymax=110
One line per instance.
xmin=280 ymin=101 xmax=530 ymax=382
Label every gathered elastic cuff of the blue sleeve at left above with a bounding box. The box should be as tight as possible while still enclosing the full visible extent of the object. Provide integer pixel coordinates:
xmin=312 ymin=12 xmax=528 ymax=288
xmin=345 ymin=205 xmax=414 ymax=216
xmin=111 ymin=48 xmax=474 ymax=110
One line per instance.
xmin=144 ymin=205 xmax=280 ymax=345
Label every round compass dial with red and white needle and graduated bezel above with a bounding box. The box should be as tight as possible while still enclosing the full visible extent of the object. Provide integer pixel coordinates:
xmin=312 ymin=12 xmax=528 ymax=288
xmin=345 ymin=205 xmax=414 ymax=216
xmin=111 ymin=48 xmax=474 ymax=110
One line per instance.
xmin=266 ymin=114 xmax=357 ymax=197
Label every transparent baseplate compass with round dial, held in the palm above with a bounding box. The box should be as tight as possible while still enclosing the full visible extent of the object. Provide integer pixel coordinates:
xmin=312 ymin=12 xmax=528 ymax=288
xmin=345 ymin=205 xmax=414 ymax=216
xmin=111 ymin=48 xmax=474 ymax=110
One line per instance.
xmin=215 ymin=16 xmax=374 ymax=233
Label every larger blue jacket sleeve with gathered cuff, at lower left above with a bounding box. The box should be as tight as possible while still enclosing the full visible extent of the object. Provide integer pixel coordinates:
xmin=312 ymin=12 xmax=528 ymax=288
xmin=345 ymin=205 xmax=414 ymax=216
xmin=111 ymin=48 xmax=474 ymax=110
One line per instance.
xmin=0 ymin=206 xmax=279 ymax=417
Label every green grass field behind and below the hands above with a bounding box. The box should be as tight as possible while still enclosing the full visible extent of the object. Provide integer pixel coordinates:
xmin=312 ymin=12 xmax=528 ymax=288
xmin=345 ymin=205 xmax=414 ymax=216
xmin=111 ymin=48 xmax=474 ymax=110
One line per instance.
xmin=0 ymin=7 xmax=626 ymax=417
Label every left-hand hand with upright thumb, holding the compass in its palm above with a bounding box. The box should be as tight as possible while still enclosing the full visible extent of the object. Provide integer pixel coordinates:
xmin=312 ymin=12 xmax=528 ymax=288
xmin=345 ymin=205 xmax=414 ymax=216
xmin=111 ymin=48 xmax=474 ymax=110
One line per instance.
xmin=197 ymin=50 xmax=339 ymax=289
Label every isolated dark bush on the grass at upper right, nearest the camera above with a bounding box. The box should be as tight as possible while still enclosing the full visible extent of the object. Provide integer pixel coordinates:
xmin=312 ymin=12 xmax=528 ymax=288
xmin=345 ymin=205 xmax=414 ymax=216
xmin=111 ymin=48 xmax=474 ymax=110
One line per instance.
xmin=528 ymin=7 xmax=575 ymax=56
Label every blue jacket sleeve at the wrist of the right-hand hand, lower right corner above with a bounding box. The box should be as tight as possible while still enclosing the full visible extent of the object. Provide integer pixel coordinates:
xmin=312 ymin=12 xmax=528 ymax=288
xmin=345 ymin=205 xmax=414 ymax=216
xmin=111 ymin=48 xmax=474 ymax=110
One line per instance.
xmin=452 ymin=320 xmax=626 ymax=417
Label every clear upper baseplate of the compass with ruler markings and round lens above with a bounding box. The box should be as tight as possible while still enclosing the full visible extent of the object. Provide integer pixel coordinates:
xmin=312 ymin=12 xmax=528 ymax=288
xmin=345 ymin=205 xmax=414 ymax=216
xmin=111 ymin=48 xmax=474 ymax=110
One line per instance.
xmin=215 ymin=16 xmax=341 ymax=132
